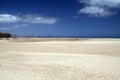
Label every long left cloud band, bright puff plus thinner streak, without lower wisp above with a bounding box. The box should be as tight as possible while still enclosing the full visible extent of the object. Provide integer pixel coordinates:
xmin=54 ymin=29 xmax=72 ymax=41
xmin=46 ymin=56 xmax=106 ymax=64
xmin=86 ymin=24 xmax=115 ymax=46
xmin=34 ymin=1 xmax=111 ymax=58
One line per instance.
xmin=0 ymin=14 xmax=58 ymax=24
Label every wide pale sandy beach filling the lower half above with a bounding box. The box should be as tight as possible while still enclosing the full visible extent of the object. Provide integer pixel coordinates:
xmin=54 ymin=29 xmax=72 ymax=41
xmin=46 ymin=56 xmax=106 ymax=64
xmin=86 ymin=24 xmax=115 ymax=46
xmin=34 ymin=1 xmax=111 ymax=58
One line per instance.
xmin=0 ymin=39 xmax=120 ymax=80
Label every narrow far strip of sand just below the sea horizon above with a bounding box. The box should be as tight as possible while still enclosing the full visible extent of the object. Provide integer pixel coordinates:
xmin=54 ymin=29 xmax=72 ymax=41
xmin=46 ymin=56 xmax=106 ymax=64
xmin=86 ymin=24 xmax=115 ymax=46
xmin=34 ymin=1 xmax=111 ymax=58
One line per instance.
xmin=8 ymin=38 xmax=120 ymax=42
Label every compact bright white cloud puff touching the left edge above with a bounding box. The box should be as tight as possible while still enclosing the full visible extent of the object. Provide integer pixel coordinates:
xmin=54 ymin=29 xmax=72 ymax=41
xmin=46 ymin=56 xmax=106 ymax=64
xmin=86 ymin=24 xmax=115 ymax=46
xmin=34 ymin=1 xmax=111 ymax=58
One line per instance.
xmin=0 ymin=14 xmax=20 ymax=23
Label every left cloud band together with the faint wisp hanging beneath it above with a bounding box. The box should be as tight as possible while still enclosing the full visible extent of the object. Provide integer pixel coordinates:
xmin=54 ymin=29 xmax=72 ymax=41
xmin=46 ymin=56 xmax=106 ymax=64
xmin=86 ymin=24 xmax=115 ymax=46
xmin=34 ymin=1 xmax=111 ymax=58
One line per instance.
xmin=0 ymin=14 xmax=59 ymax=30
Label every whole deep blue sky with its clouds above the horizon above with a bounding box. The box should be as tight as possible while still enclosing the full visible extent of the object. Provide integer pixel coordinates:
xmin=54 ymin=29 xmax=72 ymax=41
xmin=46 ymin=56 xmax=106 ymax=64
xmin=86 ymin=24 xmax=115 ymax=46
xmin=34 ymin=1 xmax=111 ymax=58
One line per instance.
xmin=0 ymin=0 xmax=120 ymax=37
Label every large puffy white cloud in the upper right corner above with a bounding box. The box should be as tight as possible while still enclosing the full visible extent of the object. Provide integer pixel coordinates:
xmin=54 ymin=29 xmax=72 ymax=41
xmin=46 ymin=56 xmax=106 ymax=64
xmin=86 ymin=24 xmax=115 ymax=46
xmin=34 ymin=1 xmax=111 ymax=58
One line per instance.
xmin=78 ymin=0 xmax=120 ymax=17
